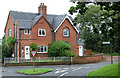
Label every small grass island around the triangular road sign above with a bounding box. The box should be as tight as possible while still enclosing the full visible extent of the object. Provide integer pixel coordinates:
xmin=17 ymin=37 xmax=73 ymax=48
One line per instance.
xmin=17 ymin=68 xmax=52 ymax=75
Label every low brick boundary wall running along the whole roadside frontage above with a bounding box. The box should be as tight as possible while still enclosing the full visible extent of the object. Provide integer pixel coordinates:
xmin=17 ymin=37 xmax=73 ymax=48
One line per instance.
xmin=5 ymin=54 xmax=103 ymax=66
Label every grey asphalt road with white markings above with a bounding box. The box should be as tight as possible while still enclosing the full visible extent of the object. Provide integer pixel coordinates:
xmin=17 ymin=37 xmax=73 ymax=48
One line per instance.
xmin=2 ymin=61 xmax=116 ymax=78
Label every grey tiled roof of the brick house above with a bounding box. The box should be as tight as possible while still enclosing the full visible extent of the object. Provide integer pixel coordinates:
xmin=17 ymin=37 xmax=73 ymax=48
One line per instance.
xmin=10 ymin=11 xmax=78 ymax=32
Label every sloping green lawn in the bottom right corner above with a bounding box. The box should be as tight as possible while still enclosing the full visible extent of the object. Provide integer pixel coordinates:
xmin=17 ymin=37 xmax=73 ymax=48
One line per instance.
xmin=88 ymin=63 xmax=120 ymax=78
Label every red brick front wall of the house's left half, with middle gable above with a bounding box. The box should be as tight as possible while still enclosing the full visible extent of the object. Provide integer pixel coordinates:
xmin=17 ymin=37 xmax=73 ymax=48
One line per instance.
xmin=21 ymin=18 xmax=53 ymax=57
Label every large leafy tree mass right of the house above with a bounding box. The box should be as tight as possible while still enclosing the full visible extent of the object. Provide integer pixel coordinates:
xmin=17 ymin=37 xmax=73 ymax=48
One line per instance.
xmin=69 ymin=0 xmax=120 ymax=52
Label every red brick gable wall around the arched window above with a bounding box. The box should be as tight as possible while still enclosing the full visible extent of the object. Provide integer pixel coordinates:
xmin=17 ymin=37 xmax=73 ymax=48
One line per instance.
xmin=56 ymin=19 xmax=79 ymax=55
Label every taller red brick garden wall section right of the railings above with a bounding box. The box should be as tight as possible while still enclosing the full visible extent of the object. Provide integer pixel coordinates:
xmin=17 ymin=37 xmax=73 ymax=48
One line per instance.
xmin=72 ymin=54 xmax=103 ymax=64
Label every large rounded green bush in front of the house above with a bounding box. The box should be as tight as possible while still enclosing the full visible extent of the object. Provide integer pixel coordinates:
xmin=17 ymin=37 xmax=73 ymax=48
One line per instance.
xmin=48 ymin=41 xmax=75 ymax=57
